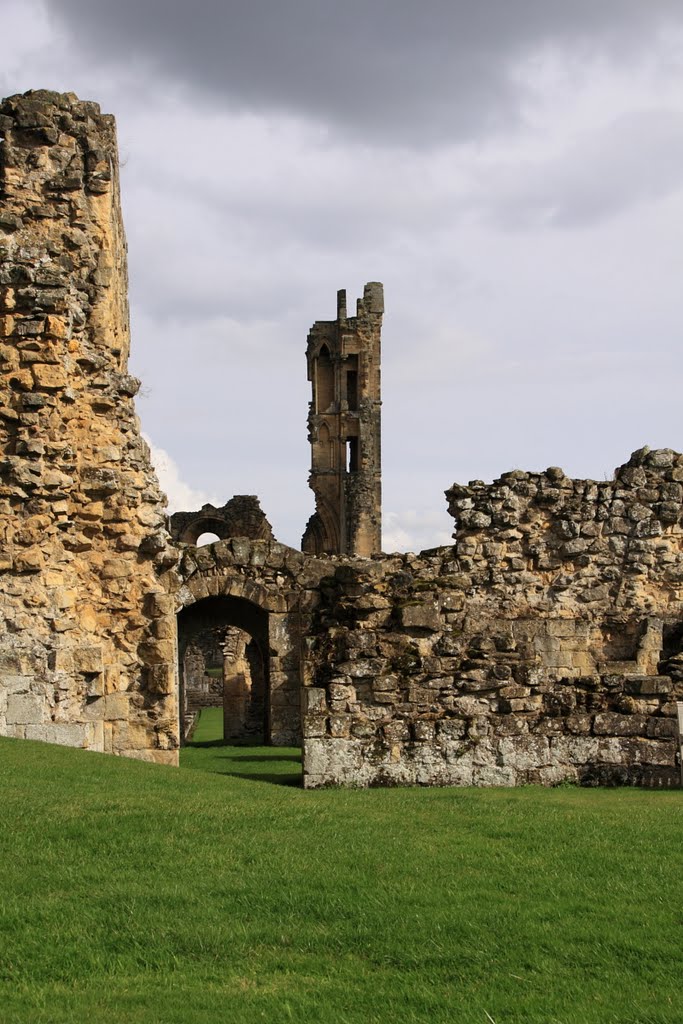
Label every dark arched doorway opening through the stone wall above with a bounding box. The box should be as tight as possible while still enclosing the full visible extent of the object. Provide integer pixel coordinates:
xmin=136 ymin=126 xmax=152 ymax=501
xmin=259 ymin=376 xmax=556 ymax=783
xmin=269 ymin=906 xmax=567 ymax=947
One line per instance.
xmin=178 ymin=595 xmax=272 ymax=743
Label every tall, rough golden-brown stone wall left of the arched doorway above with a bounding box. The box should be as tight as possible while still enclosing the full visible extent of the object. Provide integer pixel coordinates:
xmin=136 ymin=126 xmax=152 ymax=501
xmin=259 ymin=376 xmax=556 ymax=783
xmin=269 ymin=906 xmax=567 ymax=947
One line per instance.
xmin=0 ymin=92 xmax=178 ymax=764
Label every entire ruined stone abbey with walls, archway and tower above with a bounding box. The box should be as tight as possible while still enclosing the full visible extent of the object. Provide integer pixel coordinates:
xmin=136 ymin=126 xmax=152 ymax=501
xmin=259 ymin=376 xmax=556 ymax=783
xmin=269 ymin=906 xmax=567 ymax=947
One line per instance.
xmin=0 ymin=91 xmax=683 ymax=787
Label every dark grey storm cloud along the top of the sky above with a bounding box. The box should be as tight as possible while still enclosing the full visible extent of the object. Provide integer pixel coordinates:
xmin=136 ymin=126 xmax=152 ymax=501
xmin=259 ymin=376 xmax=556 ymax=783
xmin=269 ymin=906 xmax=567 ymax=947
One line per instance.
xmin=48 ymin=0 xmax=683 ymax=144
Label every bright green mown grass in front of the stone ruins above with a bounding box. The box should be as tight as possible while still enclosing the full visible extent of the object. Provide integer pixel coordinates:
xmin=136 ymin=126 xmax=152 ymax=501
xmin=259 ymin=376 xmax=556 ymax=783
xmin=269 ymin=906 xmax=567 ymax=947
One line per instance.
xmin=0 ymin=723 xmax=683 ymax=1024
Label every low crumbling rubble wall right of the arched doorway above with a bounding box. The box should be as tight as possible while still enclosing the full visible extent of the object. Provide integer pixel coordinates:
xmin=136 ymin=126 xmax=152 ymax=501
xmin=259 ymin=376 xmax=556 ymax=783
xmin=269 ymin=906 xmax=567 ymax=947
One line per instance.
xmin=304 ymin=450 xmax=683 ymax=786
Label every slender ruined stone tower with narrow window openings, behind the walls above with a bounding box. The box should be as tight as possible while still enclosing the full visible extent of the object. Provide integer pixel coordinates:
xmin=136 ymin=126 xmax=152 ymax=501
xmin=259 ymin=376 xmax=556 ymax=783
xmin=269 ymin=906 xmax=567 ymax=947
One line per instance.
xmin=301 ymin=282 xmax=384 ymax=556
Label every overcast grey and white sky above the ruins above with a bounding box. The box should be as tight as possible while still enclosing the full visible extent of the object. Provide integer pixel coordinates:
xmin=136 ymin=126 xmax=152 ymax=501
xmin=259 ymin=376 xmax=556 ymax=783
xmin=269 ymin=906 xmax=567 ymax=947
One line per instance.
xmin=0 ymin=0 xmax=683 ymax=550
